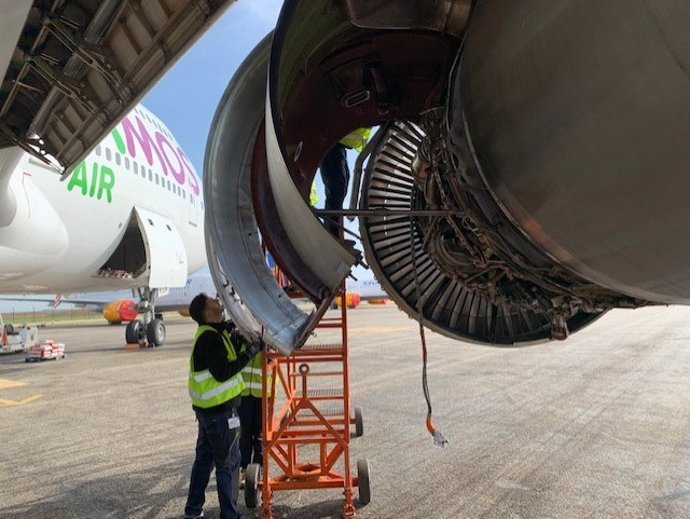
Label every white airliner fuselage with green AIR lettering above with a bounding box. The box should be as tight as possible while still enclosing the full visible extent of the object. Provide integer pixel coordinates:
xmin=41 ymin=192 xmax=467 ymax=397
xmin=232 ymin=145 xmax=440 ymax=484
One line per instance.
xmin=0 ymin=106 xmax=206 ymax=293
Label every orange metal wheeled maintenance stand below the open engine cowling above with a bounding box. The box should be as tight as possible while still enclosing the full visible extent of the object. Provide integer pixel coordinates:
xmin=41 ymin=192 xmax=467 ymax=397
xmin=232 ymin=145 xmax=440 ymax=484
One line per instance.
xmin=244 ymin=290 xmax=371 ymax=519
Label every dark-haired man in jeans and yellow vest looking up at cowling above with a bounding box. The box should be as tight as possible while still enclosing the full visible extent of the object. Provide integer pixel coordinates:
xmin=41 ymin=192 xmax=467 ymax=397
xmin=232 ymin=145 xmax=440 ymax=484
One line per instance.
xmin=184 ymin=293 xmax=263 ymax=519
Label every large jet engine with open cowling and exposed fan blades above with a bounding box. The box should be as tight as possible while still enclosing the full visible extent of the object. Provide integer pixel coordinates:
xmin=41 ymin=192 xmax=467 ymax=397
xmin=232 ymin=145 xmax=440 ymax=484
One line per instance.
xmin=204 ymin=0 xmax=690 ymax=353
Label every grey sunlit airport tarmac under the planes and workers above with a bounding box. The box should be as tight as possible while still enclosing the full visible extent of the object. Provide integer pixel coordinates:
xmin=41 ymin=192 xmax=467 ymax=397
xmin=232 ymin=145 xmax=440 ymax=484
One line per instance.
xmin=0 ymin=305 xmax=690 ymax=519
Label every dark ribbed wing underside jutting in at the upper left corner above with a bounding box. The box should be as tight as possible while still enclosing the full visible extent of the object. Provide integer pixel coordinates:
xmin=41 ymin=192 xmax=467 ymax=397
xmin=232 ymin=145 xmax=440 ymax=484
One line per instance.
xmin=0 ymin=0 xmax=235 ymax=175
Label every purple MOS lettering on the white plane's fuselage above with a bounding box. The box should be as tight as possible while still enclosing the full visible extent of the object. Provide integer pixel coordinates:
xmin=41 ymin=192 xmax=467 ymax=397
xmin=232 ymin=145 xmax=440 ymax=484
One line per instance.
xmin=121 ymin=114 xmax=199 ymax=195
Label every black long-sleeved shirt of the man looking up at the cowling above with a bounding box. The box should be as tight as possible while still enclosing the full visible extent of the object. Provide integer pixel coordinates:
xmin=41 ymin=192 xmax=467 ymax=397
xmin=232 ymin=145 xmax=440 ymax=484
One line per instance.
xmin=192 ymin=323 xmax=251 ymax=414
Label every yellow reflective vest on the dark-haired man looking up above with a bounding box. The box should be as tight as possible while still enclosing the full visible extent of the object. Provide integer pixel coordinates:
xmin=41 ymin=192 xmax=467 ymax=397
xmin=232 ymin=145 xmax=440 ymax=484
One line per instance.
xmin=187 ymin=324 xmax=245 ymax=409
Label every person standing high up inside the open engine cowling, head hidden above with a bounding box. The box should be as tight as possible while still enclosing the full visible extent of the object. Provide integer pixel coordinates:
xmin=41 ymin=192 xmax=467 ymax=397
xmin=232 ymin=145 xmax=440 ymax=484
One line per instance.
xmin=319 ymin=128 xmax=371 ymax=237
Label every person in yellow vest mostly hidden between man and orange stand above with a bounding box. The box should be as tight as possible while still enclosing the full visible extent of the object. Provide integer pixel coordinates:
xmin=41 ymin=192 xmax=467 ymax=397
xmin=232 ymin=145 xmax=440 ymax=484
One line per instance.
xmin=239 ymin=352 xmax=272 ymax=488
